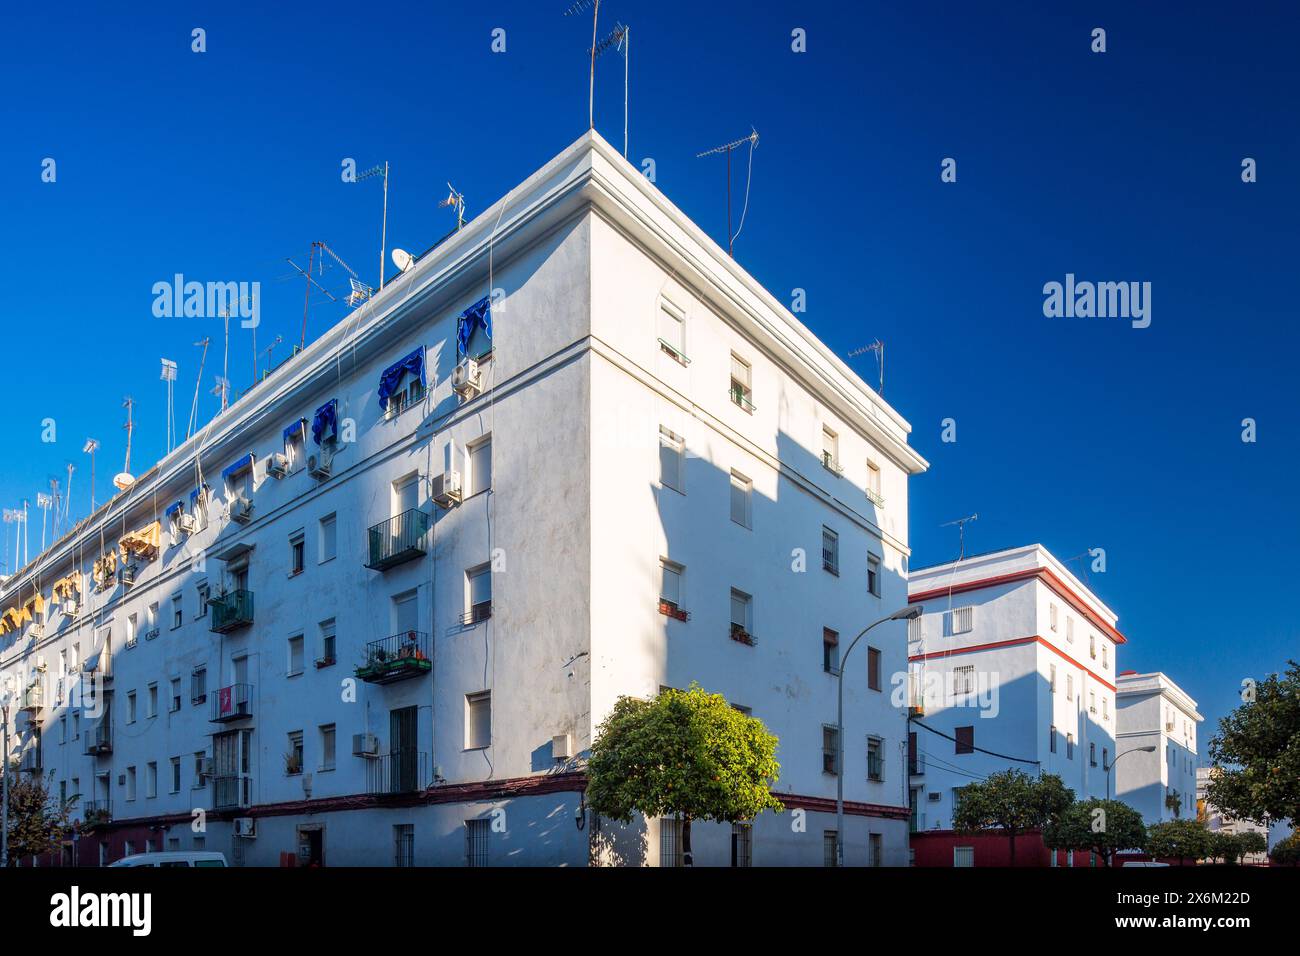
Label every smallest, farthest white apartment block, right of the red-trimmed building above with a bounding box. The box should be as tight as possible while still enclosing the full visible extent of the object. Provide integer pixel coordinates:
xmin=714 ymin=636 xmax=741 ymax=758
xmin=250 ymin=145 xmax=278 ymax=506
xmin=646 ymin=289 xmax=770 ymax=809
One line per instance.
xmin=1115 ymin=671 xmax=1204 ymax=826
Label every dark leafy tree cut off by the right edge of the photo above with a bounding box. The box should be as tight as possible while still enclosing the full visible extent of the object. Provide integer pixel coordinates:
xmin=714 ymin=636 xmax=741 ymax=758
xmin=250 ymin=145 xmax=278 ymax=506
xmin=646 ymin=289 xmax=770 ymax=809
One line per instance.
xmin=1206 ymin=661 xmax=1300 ymax=823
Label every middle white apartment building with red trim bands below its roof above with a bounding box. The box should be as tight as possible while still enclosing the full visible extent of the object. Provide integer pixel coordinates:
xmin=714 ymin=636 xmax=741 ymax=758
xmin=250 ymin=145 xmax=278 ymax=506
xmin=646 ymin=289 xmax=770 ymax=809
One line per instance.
xmin=907 ymin=545 xmax=1126 ymax=866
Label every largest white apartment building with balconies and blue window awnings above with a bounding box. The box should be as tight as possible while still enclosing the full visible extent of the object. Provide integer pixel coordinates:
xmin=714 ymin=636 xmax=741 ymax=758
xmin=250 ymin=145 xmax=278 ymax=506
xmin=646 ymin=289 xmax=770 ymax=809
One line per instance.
xmin=0 ymin=133 xmax=927 ymax=866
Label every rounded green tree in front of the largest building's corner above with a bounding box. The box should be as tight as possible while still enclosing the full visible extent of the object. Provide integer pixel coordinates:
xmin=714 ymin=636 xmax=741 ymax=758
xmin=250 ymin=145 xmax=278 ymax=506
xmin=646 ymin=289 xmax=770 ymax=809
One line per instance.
xmin=586 ymin=684 xmax=784 ymax=866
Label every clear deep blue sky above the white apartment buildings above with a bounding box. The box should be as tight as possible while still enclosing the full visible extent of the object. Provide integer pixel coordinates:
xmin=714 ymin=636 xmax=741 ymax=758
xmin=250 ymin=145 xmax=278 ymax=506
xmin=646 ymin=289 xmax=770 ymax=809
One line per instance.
xmin=0 ymin=0 xmax=1300 ymax=750
